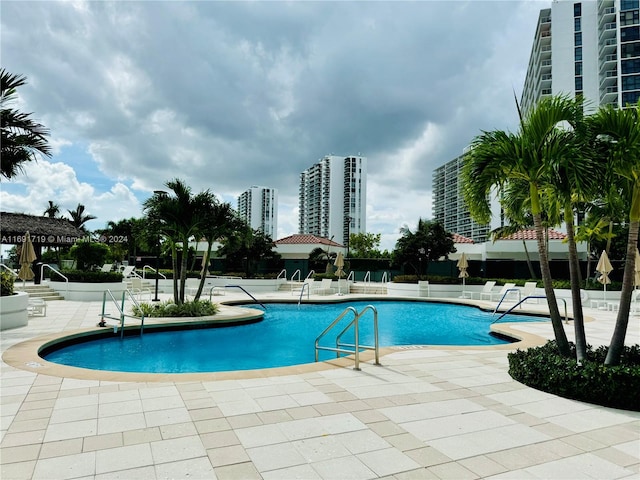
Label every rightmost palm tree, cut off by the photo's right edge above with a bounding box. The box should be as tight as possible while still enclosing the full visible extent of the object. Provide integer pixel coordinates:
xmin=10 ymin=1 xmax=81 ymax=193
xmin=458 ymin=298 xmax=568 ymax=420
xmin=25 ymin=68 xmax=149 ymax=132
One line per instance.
xmin=591 ymin=101 xmax=640 ymax=365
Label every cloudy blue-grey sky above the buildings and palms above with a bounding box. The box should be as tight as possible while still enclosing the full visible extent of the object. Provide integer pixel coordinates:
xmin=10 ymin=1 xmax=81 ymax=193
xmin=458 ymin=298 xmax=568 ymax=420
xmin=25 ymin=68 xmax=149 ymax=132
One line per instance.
xmin=0 ymin=0 xmax=550 ymax=249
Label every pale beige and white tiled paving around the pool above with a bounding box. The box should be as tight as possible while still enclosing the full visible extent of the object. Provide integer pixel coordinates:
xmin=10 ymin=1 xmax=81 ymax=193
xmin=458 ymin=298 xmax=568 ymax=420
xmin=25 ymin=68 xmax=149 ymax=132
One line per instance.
xmin=0 ymin=292 xmax=640 ymax=480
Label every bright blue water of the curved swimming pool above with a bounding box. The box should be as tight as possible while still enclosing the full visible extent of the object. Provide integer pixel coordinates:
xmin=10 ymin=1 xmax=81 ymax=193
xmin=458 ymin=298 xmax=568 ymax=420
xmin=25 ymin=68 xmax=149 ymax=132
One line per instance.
xmin=44 ymin=301 xmax=543 ymax=373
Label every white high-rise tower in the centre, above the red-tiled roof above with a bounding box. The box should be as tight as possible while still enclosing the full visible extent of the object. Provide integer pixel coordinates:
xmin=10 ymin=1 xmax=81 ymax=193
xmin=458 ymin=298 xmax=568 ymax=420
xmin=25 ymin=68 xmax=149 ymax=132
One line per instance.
xmin=299 ymin=155 xmax=367 ymax=245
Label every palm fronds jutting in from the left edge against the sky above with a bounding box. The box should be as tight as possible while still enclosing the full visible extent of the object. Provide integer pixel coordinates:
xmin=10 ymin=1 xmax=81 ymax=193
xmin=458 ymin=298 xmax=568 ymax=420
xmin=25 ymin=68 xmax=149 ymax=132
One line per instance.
xmin=0 ymin=68 xmax=51 ymax=179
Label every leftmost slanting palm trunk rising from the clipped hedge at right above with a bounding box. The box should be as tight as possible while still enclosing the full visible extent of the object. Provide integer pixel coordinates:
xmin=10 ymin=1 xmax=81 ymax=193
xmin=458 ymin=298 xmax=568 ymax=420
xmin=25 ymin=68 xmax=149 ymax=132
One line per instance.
xmin=531 ymin=201 xmax=571 ymax=357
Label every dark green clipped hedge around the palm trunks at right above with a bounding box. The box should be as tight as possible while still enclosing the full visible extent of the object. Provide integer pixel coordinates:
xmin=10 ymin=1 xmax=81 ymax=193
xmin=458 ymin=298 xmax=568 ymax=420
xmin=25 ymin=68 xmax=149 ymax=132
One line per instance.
xmin=508 ymin=341 xmax=640 ymax=411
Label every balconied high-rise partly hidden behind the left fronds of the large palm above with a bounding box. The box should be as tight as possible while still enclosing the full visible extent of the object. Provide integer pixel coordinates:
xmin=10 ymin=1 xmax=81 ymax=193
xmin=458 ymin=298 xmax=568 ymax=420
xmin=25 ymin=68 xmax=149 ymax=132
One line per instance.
xmin=433 ymin=154 xmax=492 ymax=243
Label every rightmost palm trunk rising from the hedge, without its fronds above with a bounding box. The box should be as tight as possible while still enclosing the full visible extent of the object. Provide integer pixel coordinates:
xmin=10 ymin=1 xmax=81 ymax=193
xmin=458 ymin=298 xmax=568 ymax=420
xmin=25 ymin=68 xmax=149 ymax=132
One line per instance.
xmin=604 ymin=218 xmax=640 ymax=365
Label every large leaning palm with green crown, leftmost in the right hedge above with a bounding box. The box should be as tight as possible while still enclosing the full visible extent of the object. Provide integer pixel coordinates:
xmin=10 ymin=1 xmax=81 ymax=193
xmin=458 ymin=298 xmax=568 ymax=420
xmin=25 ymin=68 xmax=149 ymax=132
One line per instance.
xmin=463 ymin=97 xmax=575 ymax=356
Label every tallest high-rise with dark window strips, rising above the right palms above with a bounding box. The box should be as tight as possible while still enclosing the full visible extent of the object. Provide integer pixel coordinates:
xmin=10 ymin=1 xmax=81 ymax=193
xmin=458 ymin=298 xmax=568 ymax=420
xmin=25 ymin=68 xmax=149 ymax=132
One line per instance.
xmin=522 ymin=0 xmax=640 ymax=113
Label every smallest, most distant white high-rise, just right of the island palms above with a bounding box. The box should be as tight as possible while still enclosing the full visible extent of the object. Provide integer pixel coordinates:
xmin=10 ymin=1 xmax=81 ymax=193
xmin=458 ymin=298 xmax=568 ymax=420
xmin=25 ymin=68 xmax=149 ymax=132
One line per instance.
xmin=238 ymin=185 xmax=278 ymax=240
